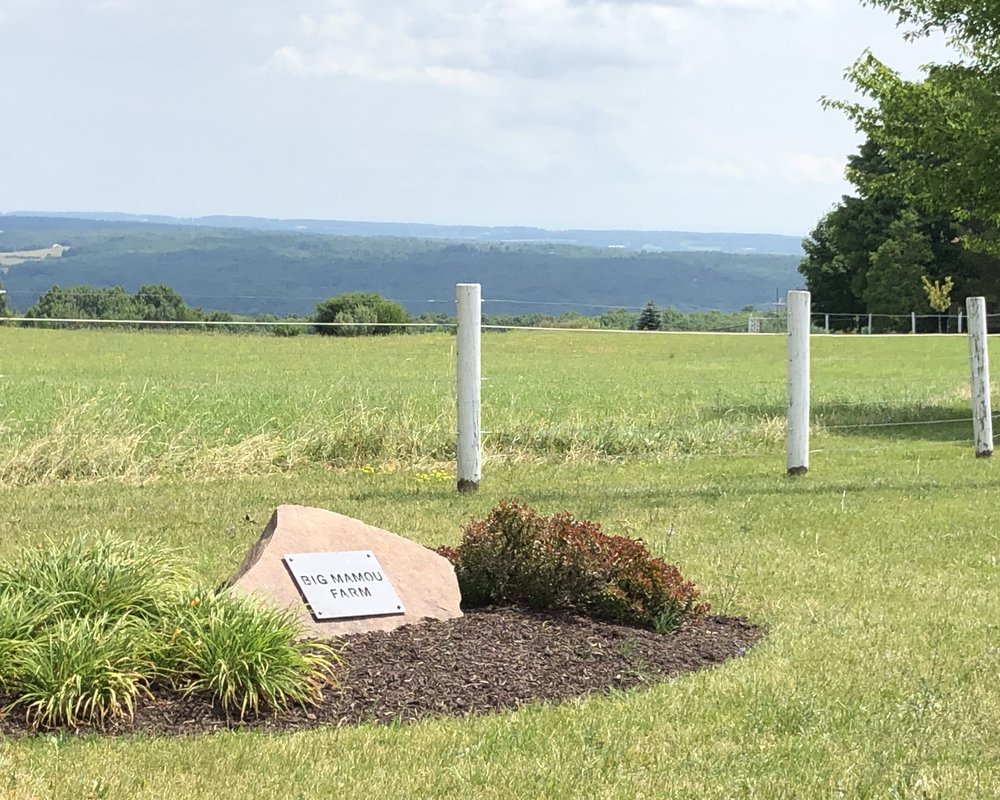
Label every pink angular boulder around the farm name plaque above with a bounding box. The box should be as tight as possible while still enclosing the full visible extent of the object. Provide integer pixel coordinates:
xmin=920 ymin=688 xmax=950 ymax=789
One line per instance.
xmin=229 ymin=505 xmax=462 ymax=637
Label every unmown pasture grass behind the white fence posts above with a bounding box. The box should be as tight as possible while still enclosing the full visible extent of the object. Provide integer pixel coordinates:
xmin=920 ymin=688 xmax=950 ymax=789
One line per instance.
xmin=0 ymin=328 xmax=984 ymax=486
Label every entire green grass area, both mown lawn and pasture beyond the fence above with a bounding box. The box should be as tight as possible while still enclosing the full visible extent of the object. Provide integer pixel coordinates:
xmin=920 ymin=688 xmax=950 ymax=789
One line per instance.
xmin=0 ymin=328 xmax=1000 ymax=800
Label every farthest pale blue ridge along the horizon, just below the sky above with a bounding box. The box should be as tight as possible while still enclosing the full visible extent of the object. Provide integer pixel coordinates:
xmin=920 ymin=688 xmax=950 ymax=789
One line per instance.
xmin=14 ymin=211 xmax=803 ymax=256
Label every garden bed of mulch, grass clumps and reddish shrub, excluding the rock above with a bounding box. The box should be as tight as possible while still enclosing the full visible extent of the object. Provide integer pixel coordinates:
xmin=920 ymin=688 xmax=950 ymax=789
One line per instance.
xmin=0 ymin=501 xmax=760 ymax=735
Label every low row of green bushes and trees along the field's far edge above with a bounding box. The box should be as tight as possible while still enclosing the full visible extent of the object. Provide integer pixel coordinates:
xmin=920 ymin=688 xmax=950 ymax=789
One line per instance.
xmin=0 ymin=284 xmax=770 ymax=336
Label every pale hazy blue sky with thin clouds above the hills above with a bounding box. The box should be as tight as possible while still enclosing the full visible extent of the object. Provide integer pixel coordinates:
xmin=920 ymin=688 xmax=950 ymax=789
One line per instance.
xmin=0 ymin=0 xmax=949 ymax=236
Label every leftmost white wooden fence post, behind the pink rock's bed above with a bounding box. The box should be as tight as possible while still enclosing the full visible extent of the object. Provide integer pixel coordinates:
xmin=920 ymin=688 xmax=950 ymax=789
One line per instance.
xmin=455 ymin=283 xmax=483 ymax=492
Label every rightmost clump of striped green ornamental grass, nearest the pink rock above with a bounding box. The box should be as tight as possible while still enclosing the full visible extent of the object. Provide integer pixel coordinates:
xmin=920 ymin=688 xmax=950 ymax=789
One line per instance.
xmin=161 ymin=590 xmax=336 ymax=718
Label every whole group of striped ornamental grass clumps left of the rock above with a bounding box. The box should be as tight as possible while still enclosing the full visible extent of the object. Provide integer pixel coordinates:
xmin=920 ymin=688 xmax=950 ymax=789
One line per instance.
xmin=0 ymin=535 xmax=337 ymax=728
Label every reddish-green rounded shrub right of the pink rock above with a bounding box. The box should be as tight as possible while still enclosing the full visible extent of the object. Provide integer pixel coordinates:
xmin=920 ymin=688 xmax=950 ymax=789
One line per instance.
xmin=438 ymin=501 xmax=708 ymax=633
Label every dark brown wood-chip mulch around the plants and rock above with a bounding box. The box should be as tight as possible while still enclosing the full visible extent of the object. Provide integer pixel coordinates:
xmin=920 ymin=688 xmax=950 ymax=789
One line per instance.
xmin=0 ymin=608 xmax=763 ymax=736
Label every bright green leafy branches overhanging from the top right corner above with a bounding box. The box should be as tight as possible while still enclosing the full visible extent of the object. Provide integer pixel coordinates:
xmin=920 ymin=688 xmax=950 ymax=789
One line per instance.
xmin=827 ymin=0 xmax=1000 ymax=254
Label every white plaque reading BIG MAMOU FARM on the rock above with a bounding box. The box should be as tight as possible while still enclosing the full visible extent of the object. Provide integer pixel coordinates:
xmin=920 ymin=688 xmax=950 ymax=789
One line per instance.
xmin=283 ymin=550 xmax=406 ymax=620
